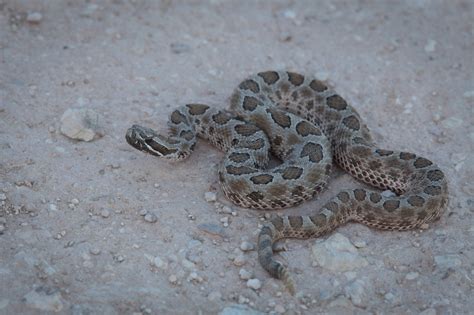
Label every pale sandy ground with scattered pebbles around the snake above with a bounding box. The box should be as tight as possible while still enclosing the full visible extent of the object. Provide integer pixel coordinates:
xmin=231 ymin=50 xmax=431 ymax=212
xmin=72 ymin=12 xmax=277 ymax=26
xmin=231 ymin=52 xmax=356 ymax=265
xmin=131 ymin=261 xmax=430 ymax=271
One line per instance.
xmin=0 ymin=0 xmax=474 ymax=315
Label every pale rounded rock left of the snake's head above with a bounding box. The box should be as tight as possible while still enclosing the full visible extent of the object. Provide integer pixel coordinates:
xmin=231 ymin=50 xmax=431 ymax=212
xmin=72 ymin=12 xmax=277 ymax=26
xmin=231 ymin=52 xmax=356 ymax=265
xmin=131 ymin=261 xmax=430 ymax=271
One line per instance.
xmin=60 ymin=108 xmax=103 ymax=141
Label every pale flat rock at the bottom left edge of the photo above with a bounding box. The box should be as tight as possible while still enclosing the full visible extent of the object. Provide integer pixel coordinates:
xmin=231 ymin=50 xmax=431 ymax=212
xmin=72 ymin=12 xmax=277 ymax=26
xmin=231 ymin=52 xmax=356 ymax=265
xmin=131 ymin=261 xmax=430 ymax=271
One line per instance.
xmin=23 ymin=287 xmax=64 ymax=312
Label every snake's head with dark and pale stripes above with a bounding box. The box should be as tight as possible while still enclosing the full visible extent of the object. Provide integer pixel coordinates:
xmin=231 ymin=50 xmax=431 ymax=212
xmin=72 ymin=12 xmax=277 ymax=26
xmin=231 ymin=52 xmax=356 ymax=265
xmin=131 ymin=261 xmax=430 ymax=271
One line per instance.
xmin=125 ymin=125 xmax=180 ymax=160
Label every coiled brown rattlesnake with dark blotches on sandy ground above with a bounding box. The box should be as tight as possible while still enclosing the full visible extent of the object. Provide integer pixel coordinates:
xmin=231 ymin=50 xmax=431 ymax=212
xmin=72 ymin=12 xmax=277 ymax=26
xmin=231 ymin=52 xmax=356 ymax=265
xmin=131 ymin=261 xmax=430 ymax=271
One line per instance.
xmin=126 ymin=71 xmax=448 ymax=293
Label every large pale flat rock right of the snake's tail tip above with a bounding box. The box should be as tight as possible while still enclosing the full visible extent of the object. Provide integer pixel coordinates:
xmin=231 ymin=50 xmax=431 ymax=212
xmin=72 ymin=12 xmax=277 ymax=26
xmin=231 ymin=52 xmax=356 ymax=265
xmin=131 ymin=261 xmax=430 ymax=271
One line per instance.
xmin=312 ymin=233 xmax=368 ymax=272
